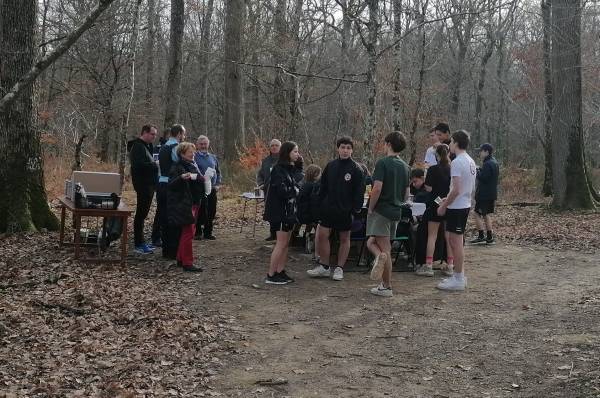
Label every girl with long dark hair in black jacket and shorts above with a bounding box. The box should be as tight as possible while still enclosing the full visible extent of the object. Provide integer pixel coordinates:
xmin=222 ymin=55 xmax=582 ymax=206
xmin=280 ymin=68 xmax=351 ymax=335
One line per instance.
xmin=264 ymin=141 xmax=300 ymax=285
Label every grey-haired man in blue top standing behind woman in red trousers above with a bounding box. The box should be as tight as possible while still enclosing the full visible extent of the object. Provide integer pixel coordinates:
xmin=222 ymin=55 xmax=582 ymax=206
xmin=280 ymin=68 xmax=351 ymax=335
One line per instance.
xmin=194 ymin=135 xmax=221 ymax=240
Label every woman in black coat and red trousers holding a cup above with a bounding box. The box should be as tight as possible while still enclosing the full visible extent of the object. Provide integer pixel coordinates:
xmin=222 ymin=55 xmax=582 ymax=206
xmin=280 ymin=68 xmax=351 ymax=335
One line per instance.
xmin=167 ymin=142 xmax=205 ymax=272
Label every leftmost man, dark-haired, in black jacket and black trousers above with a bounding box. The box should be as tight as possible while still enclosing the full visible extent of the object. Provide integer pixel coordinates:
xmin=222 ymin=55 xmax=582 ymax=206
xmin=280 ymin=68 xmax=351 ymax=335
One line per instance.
xmin=127 ymin=125 xmax=158 ymax=254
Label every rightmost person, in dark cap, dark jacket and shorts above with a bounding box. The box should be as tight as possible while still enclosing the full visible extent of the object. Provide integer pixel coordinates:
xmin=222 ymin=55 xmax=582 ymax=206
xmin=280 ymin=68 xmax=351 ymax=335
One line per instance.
xmin=470 ymin=143 xmax=500 ymax=245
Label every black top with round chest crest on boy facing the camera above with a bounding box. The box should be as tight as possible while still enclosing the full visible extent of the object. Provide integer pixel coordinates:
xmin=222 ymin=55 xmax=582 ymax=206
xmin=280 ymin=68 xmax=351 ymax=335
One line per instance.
xmin=319 ymin=159 xmax=365 ymax=214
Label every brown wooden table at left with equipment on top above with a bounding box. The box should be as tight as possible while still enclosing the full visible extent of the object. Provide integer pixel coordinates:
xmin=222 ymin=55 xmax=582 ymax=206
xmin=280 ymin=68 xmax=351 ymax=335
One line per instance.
xmin=58 ymin=195 xmax=132 ymax=265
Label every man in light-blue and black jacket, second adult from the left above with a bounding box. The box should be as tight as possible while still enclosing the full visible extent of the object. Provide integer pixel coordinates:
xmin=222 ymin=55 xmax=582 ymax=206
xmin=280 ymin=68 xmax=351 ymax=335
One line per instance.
xmin=156 ymin=124 xmax=186 ymax=260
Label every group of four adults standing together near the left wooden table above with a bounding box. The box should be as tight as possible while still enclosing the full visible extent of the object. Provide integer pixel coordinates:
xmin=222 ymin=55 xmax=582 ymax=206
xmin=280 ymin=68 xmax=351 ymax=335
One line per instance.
xmin=129 ymin=124 xmax=221 ymax=272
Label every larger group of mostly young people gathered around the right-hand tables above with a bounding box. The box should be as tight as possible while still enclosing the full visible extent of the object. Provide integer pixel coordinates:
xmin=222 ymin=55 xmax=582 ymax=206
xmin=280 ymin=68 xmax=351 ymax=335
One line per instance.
xmin=257 ymin=123 xmax=499 ymax=297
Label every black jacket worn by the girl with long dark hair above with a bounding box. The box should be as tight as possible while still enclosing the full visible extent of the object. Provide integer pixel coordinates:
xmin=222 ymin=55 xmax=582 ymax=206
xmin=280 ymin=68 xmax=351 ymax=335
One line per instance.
xmin=264 ymin=163 xmax=299 ymax=224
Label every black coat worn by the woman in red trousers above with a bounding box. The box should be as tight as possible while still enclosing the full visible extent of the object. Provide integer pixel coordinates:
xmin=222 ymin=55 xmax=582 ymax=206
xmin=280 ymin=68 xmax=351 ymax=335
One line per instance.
xmin=167 ymin=160 xmax=204 ymax=226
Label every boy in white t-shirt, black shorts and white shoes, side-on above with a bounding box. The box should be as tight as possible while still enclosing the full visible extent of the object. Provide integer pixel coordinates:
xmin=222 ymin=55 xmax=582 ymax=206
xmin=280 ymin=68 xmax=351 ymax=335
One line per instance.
xmin=437 ymin=130 xmax=477 ymax=290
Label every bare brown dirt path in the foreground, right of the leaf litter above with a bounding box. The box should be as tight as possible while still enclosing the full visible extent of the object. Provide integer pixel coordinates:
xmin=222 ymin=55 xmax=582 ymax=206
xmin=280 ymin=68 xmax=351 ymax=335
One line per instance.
xmin=185 ymin=225 xmax=600 ymax=397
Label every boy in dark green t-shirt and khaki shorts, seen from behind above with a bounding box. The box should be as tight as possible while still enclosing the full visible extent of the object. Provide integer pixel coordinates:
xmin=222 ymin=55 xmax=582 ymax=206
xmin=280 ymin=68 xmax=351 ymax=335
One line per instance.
xmin=367 ymin=131 xmax=410 ymax=297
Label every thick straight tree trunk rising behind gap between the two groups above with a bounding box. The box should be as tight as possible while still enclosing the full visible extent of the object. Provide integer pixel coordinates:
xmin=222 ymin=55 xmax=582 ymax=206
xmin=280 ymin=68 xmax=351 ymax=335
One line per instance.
xmin=223 ymin=0 xmax=246 ymax=163
